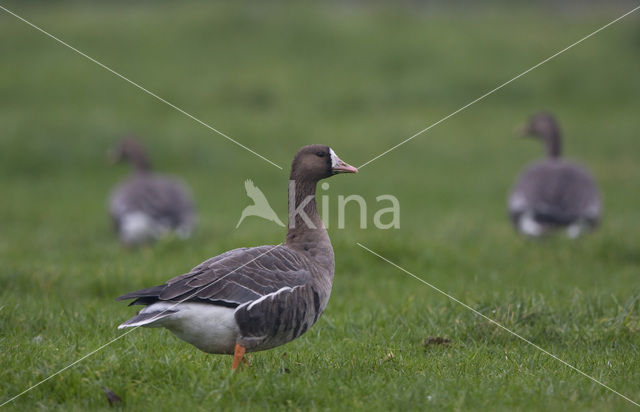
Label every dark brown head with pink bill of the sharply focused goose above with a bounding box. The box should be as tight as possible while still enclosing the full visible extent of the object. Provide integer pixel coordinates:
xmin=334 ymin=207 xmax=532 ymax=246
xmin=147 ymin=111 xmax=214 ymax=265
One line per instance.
xmin=291 ymin=144 xmax=358 ymax=181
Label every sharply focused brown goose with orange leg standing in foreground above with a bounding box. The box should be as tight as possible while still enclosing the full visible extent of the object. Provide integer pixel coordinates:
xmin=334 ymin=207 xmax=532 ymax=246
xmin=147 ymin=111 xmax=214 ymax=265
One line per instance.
xmin=117 ymin=145 xmax=358 ymax=370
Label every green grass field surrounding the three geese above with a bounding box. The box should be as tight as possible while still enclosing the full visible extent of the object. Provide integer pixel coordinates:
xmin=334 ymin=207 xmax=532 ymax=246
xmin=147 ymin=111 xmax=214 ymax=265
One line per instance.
xmin=0 ymin=1 xmax=640 ymax=411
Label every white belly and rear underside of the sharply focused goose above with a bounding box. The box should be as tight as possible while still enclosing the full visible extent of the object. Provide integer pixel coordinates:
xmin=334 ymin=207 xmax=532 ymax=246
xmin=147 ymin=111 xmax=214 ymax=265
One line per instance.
xmin=144 ymin=302 xmax=240 ymax=354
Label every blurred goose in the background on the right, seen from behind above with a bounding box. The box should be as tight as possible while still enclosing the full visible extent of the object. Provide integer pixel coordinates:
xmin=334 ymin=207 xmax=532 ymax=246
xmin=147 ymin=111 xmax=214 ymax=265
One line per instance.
xmin=508 ymin=112 xmax=602 ymax=238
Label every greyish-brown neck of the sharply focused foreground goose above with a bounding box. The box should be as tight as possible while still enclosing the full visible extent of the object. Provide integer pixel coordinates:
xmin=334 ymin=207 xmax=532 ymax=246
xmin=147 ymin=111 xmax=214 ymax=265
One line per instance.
xmin=285 ymin=174 xmax=333 ymax=273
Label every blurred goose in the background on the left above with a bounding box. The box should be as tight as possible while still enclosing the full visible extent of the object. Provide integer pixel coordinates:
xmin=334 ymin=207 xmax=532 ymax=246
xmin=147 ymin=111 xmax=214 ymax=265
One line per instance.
xmin=109 ymin=138 xmax=195 ymax=246
